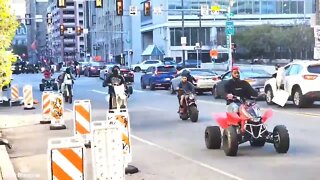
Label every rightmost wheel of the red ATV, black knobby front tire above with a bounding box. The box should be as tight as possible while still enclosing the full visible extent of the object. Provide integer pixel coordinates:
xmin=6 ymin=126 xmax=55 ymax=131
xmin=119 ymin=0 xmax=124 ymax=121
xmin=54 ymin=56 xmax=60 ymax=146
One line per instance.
xmin=273 ymin=125 xmax=290 ymax=153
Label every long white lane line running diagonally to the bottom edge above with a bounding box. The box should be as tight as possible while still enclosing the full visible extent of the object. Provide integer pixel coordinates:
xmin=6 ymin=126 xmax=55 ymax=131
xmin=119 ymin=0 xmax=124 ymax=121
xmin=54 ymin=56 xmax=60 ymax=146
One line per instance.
xmin=131 ymin=134 xmax=243 ymax=180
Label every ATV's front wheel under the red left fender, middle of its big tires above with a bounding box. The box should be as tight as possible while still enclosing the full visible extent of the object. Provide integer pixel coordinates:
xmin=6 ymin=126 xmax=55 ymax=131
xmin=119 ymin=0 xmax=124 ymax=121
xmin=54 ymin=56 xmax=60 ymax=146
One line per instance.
xmin=223 ymin=126 xmax=239 ymax=156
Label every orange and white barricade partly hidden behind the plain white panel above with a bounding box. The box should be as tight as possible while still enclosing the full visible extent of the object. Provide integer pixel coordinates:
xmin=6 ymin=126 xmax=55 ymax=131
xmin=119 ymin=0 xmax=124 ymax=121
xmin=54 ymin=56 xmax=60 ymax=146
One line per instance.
xmin=107 ymin=109 xmax=132 ymax=166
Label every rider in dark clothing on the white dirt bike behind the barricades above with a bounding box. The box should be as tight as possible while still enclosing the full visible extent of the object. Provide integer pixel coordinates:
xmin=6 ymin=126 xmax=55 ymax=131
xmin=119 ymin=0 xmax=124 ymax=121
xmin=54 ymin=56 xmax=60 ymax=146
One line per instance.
xmin=104 ymin=66 xmax=125 ymax=109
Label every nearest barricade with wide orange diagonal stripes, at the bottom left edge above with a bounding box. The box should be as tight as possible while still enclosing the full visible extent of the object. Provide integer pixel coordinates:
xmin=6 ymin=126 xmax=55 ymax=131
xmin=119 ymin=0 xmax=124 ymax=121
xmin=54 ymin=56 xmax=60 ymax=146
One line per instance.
xmin=48 ymin=137 xmax=86 ymax=180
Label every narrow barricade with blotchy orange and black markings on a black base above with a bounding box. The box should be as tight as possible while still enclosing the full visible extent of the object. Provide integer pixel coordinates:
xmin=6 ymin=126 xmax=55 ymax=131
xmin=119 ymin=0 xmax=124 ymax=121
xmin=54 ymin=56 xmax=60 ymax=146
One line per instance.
xmin=50 ymin=92 xmax=67 ymax=130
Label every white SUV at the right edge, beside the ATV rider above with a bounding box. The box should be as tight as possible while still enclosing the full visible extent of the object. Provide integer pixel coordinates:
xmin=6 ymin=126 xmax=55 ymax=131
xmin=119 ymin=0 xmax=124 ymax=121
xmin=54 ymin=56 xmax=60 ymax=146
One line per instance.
xmin=264 ymin=60 xmax=320 ymax=107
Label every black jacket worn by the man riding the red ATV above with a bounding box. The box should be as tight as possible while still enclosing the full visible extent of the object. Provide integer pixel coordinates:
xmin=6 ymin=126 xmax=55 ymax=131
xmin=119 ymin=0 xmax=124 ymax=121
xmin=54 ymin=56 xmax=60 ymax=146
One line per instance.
xmin=224 ymin=79 xmax=258 ymax=104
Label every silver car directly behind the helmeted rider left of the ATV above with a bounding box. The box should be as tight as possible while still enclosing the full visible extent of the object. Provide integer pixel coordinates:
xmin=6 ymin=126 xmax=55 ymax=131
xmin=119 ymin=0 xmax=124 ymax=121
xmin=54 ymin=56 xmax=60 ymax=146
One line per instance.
xmin=170 ymin=68 xmax=219 ymax=94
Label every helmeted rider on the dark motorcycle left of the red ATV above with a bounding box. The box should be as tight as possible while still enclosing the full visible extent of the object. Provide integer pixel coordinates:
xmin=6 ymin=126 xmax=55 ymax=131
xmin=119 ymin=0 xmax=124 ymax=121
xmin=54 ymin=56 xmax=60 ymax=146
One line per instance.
xmin=178 ymin=73 xmax=195 ymax=112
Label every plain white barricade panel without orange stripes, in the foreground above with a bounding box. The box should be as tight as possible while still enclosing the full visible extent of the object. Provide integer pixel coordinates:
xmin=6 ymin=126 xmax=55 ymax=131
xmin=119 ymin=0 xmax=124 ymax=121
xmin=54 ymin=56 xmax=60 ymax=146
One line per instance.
xmin=91 ymin=121 xmax=125 ymax=180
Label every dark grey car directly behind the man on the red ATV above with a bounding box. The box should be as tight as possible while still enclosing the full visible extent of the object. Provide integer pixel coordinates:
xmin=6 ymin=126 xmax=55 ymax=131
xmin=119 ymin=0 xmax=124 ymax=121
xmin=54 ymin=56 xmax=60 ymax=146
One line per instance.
xmin=212 ymin=69 xmax=272 ymax=98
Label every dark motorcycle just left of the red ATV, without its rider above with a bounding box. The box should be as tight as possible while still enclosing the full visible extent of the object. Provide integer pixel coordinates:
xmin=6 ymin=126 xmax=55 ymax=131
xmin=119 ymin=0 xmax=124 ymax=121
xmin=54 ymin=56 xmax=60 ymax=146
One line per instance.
xmin=178 ymin=89 xmax=199 ymax=122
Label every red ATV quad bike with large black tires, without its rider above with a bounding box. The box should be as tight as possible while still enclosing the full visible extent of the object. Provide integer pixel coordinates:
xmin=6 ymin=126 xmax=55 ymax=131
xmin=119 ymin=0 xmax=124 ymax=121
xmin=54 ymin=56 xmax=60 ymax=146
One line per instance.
xmin=205 ymin=97 xmax=290 ymax=156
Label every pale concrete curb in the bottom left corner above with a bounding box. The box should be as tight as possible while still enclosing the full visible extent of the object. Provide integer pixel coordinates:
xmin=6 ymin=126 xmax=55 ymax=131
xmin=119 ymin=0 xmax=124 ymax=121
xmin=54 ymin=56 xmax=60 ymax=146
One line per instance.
xmin=0 ymin=145 xmax=17 ymax=180
